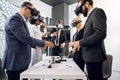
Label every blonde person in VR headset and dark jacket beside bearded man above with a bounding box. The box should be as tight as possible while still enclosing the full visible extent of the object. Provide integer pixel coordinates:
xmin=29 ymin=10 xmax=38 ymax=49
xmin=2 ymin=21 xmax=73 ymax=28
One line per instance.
xmin=69 ymin=17 xmax=85 ymax=72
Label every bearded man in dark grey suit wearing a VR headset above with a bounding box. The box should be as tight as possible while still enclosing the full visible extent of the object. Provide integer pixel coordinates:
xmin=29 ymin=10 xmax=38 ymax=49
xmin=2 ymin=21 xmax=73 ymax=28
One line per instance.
xmin=74 ymin=0 xmax=107 ymax=80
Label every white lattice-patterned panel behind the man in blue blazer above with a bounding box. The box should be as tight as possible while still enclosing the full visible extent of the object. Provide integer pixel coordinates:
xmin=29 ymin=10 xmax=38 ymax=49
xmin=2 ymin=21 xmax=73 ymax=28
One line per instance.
xmin=0 ymin=0 xmax=19 ymax=58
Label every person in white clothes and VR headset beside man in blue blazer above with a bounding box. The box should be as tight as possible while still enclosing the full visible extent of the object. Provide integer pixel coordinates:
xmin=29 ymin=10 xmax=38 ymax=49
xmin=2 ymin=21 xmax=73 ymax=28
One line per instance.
xmin=29 ymin=11 xmax=49 ymax=65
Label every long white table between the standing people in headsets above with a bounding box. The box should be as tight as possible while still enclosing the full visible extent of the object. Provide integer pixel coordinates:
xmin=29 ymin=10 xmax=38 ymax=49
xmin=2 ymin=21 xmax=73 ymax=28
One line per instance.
xmin=20 ymin=58 xmax=86 ymax=80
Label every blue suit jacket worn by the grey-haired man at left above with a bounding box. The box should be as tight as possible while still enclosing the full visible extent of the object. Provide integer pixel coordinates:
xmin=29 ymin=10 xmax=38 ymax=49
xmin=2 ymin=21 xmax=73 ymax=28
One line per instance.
xmin=2 ymin=13 xmax=45 ymax=71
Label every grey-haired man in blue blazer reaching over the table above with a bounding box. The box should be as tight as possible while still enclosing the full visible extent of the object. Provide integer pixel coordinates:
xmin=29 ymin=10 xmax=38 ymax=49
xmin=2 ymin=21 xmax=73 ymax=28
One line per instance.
xmin=2 ymin=2 xmax=54 ymax=80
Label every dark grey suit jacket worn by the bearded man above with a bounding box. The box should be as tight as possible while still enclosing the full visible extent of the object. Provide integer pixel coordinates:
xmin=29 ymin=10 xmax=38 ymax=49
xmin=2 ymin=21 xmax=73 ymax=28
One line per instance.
xmin=80 ymin=8 xmax=107 ymax=62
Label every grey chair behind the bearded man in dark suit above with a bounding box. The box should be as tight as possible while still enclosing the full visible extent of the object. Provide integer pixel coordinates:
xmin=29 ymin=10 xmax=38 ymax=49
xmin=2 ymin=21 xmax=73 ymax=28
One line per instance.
xmin=103 ymin=55 xmax=113 ymax=80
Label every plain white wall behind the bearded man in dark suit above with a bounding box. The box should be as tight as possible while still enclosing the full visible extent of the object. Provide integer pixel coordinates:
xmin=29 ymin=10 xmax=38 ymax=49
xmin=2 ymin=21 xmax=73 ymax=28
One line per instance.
xmin=69 ymin=0 xmax=120 ymax=71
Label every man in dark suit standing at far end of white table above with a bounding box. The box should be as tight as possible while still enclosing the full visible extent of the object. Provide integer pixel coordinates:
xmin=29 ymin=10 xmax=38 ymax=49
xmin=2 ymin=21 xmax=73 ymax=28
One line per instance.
xmin=51 ymin=20 xmax=65 ymax=56
